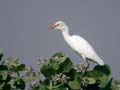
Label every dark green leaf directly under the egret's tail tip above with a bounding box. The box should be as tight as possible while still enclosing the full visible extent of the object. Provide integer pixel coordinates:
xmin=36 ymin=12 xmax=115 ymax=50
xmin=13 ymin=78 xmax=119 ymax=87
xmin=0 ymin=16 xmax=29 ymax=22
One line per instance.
xmin=94 ymin=64 xmax=111 ymax=75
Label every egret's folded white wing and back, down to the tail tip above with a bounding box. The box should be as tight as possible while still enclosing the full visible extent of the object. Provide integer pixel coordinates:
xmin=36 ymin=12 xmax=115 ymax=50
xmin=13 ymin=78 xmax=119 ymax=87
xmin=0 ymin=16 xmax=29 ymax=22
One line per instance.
xmin=70 ymin=35 xmax=104 ymax=65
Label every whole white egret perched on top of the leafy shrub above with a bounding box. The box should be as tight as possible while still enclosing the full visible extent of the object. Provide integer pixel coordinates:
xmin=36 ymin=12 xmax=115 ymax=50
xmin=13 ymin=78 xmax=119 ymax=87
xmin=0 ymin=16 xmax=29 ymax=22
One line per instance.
xmin=49 ymin=21 xmax=104 ymax=68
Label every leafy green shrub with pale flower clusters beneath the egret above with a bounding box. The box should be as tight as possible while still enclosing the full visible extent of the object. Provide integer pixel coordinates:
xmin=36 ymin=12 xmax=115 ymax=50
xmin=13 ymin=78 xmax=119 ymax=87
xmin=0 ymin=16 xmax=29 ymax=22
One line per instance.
xmin=0 ymin=52 xmax=120 ymax=90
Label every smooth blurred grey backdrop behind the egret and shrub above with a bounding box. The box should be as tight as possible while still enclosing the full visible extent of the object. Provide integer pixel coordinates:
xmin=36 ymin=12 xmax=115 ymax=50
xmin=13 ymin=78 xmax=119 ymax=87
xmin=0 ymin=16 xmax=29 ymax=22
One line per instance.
xmin=0 ymin=0 xmax=120 ymax=76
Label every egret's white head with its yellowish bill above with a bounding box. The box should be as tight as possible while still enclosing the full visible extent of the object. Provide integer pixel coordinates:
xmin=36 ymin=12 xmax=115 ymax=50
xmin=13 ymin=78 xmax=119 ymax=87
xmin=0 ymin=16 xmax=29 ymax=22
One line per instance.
xmin=49 ymin=21 xmax=67 ymax=31
